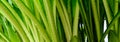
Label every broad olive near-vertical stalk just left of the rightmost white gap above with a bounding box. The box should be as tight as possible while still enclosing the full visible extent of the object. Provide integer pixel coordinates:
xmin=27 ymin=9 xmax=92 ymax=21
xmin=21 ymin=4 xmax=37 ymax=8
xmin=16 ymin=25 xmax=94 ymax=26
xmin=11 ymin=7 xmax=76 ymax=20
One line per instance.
xmin=91 ymin=0 xmax=101 ymax=42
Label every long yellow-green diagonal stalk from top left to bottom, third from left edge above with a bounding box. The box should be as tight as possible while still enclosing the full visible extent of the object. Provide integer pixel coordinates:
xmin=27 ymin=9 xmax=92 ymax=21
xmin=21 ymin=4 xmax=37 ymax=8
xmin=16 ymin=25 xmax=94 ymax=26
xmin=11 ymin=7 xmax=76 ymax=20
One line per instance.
xmin=14 ymin=0 xmax=50 ymax=42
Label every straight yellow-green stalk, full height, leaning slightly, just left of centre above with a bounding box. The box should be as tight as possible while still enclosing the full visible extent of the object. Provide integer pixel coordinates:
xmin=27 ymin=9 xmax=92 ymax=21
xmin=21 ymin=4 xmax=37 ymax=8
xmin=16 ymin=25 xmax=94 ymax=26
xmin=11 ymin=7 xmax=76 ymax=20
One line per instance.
xmin=43 ymin=0 xmax=59 ymax=42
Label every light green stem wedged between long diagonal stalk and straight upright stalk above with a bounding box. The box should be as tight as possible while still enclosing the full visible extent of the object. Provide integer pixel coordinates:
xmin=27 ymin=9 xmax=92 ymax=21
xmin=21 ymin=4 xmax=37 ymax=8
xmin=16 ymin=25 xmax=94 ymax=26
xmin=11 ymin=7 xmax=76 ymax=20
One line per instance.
xmin=34 ymin=0 xmax=52 ymax=41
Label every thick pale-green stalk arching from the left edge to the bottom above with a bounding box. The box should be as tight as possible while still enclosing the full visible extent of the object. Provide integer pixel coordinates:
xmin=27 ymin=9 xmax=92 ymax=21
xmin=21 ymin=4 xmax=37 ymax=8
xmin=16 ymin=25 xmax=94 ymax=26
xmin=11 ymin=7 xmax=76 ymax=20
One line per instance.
xmin=0 ymin=2 xmax=29 ymax=42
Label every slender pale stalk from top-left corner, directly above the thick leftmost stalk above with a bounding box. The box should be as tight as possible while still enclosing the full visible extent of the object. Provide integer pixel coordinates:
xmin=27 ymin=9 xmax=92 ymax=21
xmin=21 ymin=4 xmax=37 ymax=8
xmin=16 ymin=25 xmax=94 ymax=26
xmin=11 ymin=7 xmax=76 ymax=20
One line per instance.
xmin=2 ymin=0 xmax=34 ymax=41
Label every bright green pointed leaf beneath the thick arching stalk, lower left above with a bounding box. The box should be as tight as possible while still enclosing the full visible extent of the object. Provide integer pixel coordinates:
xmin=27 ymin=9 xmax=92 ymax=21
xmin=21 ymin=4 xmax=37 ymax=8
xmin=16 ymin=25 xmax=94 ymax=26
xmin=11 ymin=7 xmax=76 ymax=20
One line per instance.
xmin=4 ymin=20 xmax=21 ymax=42
